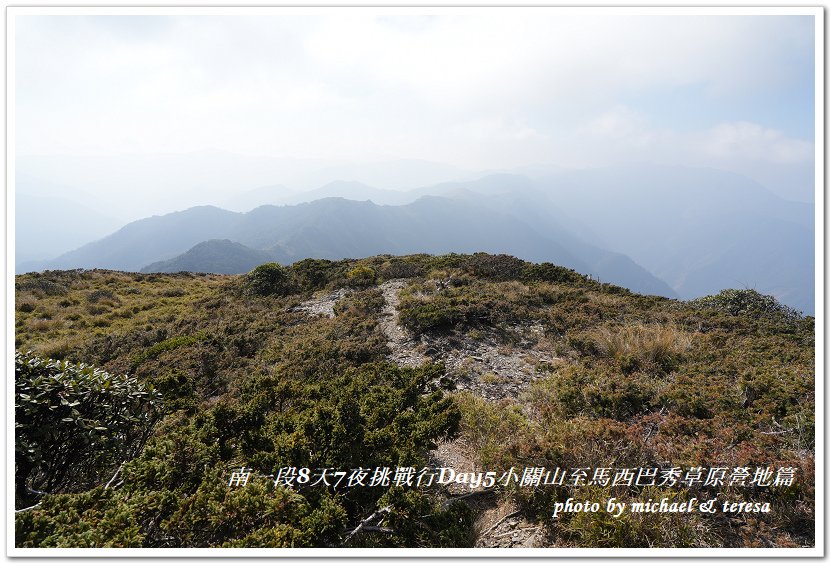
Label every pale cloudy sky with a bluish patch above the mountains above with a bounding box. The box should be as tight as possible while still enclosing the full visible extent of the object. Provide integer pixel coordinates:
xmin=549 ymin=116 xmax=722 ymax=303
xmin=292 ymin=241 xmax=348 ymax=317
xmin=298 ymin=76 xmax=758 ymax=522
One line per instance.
xmin=14 ymin=8 xmax=815 ymax=205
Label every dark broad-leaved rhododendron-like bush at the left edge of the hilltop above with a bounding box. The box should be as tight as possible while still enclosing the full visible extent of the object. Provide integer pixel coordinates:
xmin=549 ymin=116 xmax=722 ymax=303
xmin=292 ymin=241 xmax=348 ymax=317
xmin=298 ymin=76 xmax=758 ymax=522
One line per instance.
xmin=14 ymin=352 xmax=161 ymax=506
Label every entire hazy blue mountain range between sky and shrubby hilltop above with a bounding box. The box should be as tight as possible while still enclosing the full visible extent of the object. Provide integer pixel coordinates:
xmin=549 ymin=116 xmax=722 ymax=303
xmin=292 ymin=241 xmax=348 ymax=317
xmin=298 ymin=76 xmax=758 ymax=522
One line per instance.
xmin=21 ymin=166 xmax=815 ymax=314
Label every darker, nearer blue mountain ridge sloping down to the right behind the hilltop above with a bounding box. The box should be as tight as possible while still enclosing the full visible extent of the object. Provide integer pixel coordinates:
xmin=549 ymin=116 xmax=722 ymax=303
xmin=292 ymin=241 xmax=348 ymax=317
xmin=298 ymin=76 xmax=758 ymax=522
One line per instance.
xmin=35 ymin=196 xmax=676 ymax=297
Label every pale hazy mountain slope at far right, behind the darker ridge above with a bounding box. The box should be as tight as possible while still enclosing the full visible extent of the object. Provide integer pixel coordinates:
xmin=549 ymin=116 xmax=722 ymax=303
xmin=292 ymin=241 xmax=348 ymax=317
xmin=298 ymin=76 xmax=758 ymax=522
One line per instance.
xmin=540 ymin=166 xmax=815 ymax=314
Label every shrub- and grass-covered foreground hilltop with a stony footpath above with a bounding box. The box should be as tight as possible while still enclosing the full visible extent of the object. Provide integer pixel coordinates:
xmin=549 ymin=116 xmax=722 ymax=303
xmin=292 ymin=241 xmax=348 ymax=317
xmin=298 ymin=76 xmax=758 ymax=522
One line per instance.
xmin=14 ymin=254 xmax=816 ymax=548
